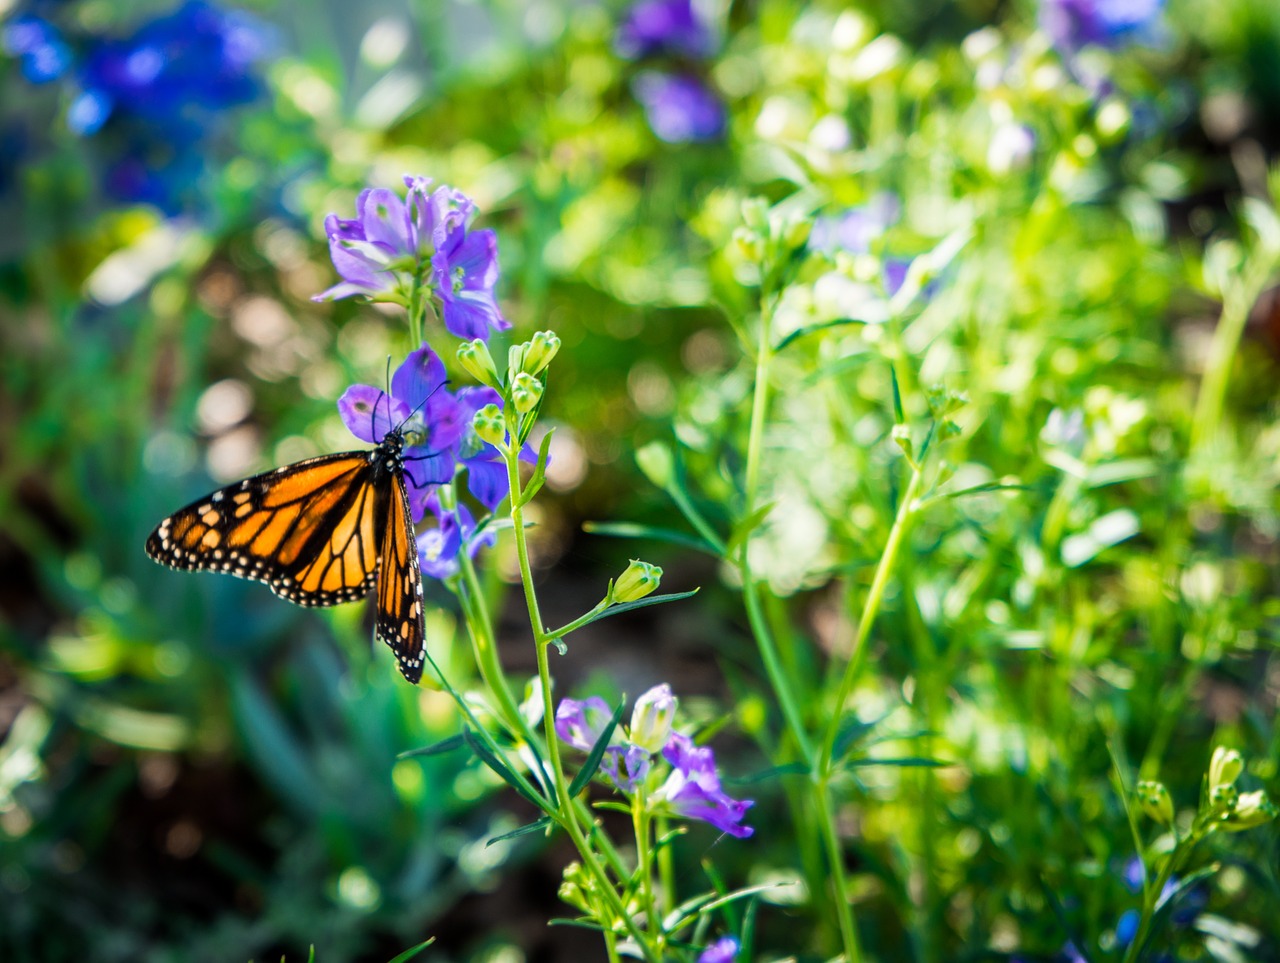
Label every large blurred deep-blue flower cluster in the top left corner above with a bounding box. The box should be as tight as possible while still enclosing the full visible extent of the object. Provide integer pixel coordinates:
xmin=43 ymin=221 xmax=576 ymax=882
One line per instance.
xmin=3 ymin=0 xmax=273 ymax=215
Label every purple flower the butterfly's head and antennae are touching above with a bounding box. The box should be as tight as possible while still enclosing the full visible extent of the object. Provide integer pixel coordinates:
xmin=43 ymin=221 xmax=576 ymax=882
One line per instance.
xmin=338 ymin=344 xmax=466 ymax=521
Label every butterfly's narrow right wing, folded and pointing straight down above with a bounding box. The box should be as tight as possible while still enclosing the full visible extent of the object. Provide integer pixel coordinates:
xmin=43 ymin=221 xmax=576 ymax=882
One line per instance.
xmin=374 ymin=473 xmax=426 ymax=684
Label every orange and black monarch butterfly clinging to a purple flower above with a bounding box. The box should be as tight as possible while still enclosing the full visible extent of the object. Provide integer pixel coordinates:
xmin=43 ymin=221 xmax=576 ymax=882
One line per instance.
xmin=147 ymin=426 xmax=426 ymax=684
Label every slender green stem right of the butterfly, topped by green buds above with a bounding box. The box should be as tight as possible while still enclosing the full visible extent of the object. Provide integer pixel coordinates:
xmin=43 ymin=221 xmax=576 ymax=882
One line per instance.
xmin=503 ymin=427 xmax=659 ymax=963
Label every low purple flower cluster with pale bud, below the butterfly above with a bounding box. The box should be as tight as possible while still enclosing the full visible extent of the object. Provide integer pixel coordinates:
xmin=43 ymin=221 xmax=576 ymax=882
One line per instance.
xmin=556 ymin=684 xmax=754 ymax=839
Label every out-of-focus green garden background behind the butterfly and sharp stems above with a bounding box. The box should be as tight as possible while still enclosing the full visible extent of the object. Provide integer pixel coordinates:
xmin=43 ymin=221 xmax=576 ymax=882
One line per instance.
xmin=0 ymin=0 xmax=1280 ymax=963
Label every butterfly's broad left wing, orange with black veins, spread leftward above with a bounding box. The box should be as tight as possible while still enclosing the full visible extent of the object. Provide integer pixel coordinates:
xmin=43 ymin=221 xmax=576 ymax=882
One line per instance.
xmin=147 ymin=452 xmax=378 ymax=604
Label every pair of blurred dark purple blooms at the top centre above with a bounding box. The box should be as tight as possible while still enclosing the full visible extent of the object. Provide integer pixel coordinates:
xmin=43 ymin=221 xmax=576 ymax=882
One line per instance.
xmin=614 ymin=0 xmax=726 ymax=143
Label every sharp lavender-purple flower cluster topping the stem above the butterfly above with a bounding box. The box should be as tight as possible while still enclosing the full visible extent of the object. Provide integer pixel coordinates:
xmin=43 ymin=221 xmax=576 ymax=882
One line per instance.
xmin=314 ymin=177 xmax=511 ymax=339
